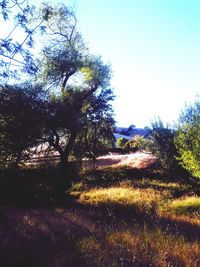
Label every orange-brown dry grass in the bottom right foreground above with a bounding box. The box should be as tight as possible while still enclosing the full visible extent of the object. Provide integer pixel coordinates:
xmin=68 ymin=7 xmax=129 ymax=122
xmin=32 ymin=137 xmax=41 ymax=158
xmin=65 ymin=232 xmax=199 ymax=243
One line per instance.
xmin=77 ymin=228 xmax=200 ymax=267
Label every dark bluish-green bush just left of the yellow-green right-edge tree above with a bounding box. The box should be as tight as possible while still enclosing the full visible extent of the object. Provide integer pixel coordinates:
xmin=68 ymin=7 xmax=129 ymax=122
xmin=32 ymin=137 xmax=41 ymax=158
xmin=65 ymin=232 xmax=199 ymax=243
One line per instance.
xmin=148 ymin=119 xmax=178 ymax=170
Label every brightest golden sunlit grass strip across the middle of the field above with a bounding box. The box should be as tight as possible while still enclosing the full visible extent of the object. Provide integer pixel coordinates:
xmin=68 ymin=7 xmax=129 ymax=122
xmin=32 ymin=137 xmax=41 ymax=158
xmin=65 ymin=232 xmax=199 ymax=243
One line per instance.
xmin=71 ymin=178 xmax=200 ymax=224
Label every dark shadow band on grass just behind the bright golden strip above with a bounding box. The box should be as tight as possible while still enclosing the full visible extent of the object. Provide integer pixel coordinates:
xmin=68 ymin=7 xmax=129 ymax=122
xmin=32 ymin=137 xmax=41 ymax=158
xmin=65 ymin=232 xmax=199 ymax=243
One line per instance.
xmin=77 ymin=165 xmax=200 ymax=197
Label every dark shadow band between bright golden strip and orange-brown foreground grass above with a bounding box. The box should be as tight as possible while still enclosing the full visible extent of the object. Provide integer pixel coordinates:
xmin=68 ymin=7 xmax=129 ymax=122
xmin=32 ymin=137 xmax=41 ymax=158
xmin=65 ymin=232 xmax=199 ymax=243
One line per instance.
xmin=69 ymin=199 xmax=200 ymax=245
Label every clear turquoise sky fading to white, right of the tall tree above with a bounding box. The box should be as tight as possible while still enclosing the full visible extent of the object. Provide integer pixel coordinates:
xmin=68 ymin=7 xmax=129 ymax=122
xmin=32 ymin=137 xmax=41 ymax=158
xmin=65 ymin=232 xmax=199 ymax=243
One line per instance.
xmin=33 ymin=0 xmax=200 ymax=127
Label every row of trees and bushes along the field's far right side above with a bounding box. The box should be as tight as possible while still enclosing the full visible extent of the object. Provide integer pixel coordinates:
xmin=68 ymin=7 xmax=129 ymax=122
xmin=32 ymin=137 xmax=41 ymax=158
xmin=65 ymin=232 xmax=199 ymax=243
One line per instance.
xmin=117 ymin=97 xmax=200 ymax=178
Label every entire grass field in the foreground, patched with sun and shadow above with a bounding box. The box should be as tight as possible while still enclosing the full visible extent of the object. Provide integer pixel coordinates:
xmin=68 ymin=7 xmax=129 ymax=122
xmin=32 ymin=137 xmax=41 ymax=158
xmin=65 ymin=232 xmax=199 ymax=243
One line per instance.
xmin=0 ymin=156 xmax=200 ymax=267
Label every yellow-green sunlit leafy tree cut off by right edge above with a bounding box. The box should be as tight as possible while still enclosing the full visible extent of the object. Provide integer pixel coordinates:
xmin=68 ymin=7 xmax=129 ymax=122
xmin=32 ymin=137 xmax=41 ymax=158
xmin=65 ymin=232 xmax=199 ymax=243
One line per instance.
xmin=175 ymin=99 xmax=200 ymax=178
